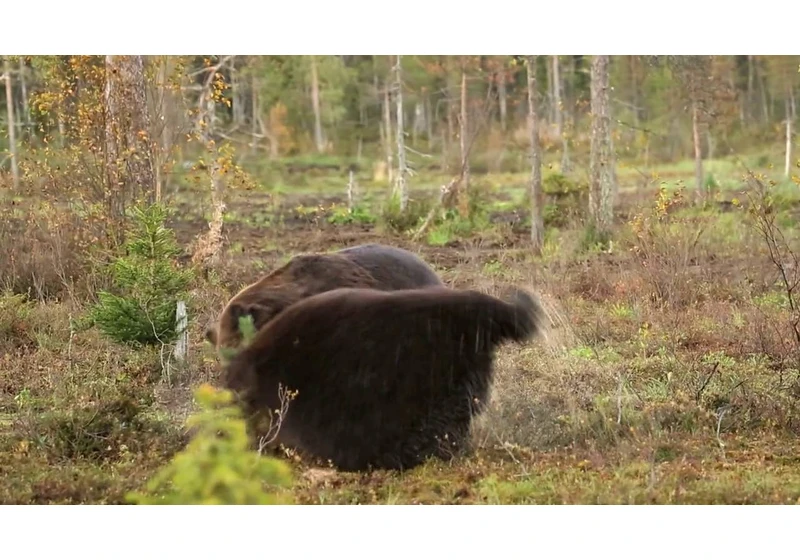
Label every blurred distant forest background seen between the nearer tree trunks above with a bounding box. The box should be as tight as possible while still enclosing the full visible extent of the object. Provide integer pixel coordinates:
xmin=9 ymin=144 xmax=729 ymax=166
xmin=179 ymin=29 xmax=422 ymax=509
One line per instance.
xmin=0 ymin=55 xmax=800 ymax=173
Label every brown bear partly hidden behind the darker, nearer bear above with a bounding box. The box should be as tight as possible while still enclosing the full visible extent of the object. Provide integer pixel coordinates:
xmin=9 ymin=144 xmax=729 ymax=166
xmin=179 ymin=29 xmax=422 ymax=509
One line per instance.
xmin=206 ymin=243 xmax=443 ymax=357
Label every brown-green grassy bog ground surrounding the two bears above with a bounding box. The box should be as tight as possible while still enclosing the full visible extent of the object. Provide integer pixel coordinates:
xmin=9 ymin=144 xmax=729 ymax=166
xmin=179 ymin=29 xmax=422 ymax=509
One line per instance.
xmin=0 ymin=148 xmax=800 ymax=504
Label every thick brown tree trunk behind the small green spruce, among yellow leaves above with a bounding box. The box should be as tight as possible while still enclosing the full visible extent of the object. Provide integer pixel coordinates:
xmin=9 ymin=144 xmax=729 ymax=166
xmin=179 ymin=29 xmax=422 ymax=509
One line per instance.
xmin=105 ymin=55 xmax=156 ymax=242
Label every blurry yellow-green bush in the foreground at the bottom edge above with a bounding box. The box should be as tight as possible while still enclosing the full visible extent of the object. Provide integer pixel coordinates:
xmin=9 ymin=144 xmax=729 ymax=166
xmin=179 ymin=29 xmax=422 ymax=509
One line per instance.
xmin=128 ymin=384 xmax=291 ymax=505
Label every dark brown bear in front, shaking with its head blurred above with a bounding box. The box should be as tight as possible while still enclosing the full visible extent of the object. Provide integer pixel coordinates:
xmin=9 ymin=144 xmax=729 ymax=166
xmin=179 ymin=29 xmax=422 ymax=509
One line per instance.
xmin=222 ymin=287 xmax=545 ymax=471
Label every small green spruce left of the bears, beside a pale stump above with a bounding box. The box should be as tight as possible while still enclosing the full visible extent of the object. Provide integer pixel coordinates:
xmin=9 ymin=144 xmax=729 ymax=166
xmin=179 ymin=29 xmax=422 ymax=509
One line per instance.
xmin=89 ymin=205 xmax=191 ymax=344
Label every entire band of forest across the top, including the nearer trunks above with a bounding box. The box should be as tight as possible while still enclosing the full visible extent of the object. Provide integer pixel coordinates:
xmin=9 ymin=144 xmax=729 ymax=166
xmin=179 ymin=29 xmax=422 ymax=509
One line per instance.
xmin=0 ymin=55 xmax=800 ymax=296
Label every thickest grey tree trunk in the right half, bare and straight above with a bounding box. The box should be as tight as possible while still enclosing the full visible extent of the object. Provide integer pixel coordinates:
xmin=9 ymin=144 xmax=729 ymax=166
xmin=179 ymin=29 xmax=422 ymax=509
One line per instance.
xmin=589 ymin=55 xmax=616 ymax=242
